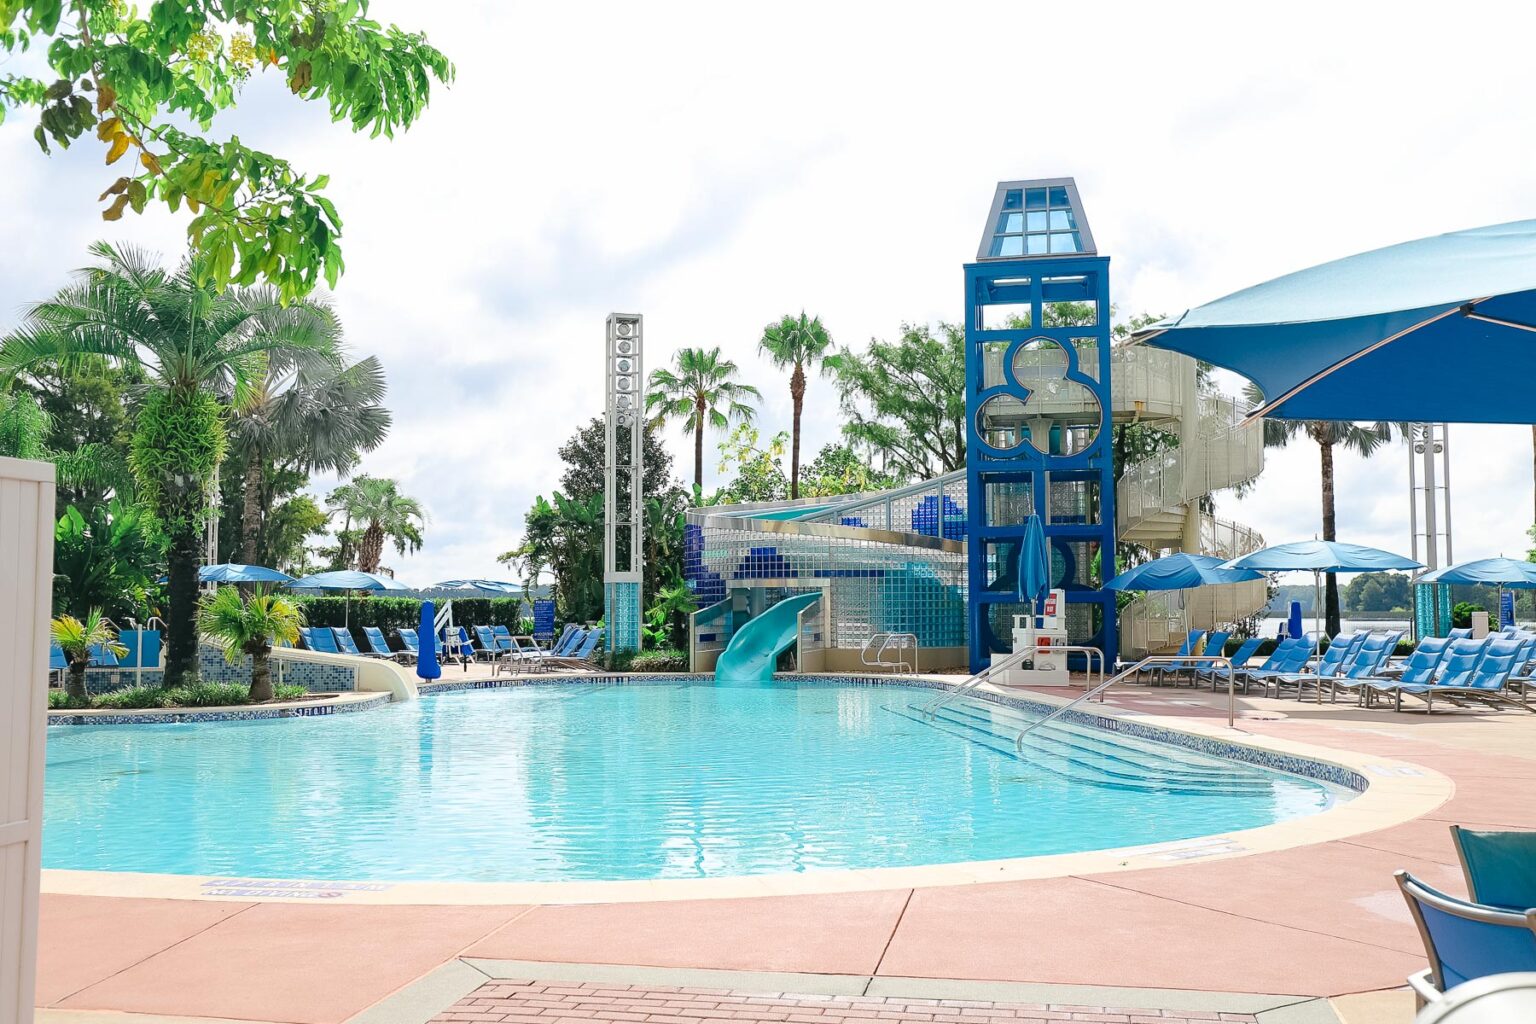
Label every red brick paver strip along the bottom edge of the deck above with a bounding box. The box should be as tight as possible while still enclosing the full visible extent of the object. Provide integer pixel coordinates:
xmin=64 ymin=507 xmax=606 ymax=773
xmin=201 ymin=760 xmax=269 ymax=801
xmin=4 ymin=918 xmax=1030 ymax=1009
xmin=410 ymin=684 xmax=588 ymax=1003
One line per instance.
xmin=432 ymin=981 xmax=1258 ymax=1024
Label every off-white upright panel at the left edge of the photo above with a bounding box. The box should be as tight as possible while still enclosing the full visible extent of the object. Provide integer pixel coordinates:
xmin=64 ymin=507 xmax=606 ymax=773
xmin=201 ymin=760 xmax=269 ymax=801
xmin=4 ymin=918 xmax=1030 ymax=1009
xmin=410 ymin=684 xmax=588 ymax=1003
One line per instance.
xmin=0 ymin=459 xmax=54 ymax=1024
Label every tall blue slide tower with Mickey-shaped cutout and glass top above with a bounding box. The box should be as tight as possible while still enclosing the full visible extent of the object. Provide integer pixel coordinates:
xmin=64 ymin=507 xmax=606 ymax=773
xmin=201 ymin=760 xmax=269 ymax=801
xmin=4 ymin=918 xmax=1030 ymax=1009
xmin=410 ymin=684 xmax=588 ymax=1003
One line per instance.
xmin=965 ymin=178 xmax=1117 ymax=671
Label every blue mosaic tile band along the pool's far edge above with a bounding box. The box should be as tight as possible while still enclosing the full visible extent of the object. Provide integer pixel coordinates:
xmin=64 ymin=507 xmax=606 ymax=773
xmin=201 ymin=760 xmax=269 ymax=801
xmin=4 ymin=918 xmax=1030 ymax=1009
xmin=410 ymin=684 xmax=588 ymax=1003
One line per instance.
xmin=418 ymin=672 xmax=1370 ymax=794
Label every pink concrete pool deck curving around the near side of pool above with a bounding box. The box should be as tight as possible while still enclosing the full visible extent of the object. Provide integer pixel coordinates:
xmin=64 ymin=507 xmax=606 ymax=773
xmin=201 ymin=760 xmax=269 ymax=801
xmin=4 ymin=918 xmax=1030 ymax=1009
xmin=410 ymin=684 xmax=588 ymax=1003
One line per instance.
xmin=37 ymin=688 xmax=1536 ymax=1024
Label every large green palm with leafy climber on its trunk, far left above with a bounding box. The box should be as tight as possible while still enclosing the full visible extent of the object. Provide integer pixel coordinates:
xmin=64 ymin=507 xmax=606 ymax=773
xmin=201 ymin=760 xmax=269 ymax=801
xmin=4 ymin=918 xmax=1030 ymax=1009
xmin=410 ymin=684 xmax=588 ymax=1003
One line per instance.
xmin=0 ymin=243 xmax=326 ymax=686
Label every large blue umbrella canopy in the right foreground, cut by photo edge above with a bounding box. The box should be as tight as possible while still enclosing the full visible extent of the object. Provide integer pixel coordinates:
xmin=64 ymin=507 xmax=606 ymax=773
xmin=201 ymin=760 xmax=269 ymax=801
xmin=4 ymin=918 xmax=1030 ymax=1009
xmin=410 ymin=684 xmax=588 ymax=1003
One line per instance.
xmin=1137 ymin=221 xmax=1536 ymax=424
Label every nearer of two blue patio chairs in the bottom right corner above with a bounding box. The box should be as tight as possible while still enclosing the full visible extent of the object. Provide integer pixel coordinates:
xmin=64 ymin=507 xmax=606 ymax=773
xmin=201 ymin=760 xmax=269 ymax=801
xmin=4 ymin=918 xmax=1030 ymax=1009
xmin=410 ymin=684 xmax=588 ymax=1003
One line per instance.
xmin=1392 ymin=870 xmax=1536 ymax=1007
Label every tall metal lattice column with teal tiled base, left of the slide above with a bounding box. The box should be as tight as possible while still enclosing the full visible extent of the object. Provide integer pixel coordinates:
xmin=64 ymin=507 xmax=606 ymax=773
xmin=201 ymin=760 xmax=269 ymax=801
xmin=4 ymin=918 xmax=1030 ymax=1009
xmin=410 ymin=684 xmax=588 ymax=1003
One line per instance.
xmin=602 ymin=313 xmax=645 ymax=651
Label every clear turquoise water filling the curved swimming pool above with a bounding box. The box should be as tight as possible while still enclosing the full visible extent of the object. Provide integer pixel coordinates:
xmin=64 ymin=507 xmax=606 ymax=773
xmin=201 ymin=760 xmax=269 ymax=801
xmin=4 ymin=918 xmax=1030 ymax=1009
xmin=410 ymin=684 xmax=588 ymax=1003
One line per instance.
xmin=43 ymin=682 xmax=1344 ymax=881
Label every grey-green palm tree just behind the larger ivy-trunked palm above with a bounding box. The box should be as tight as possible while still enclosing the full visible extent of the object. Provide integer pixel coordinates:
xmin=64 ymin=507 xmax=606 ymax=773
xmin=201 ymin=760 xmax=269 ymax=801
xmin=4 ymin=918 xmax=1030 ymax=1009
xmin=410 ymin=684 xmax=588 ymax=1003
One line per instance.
xmin=227 ymin=336 xmax=390 ymax=565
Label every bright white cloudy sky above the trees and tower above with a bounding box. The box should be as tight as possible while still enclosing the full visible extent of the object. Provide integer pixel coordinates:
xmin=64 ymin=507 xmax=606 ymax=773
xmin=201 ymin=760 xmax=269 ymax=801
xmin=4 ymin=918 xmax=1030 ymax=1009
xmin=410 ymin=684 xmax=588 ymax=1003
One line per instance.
xmin=0 ymin=0 xmax=1536 ymax=585
